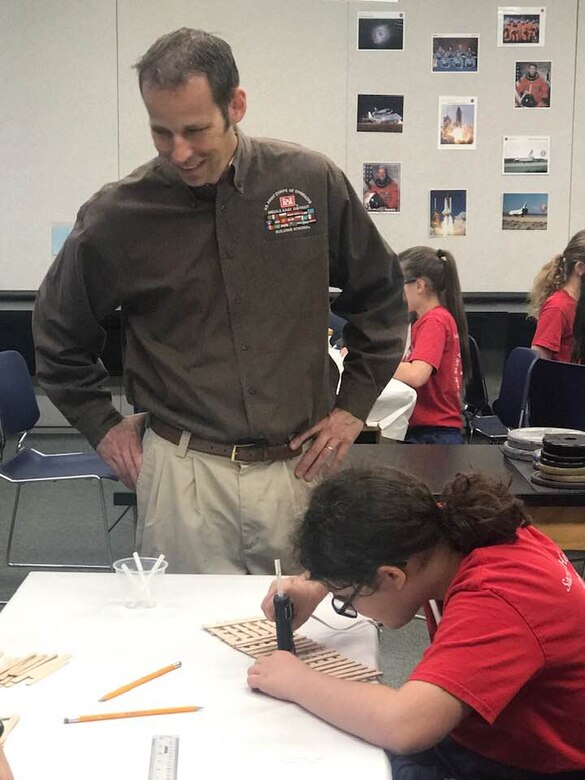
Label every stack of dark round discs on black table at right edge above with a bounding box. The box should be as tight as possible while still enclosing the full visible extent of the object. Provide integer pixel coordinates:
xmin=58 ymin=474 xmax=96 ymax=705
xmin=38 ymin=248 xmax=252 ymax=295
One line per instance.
xmin=532 ymin=431 xmax=585 ymax=490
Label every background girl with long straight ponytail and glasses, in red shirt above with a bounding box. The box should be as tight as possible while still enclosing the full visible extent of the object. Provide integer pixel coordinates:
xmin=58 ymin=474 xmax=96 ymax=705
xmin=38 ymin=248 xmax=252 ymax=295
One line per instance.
xmin=394 ymin=246 xmax=470 ymax=444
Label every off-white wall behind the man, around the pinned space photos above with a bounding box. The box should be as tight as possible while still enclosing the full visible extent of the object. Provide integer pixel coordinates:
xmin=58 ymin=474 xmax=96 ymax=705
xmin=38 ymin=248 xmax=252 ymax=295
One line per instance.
xmin=0 ymin=0 xmax=585 ymax=292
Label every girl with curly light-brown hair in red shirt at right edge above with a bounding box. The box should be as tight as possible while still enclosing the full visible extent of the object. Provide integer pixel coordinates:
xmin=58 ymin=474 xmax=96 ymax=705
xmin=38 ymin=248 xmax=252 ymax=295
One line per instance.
xmin=529 ymin=230 xmax=585 ymax=363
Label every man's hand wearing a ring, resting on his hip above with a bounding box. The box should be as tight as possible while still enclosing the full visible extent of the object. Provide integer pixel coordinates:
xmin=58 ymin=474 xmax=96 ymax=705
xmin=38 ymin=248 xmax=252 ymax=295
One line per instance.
xmin=290 ymin=409 xmax=364 ymax=482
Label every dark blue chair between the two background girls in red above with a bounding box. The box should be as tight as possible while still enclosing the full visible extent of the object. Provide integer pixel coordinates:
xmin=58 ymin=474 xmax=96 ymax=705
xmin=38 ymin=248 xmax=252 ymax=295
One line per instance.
xmin=469 ymin=347 xmax=538 ymax=444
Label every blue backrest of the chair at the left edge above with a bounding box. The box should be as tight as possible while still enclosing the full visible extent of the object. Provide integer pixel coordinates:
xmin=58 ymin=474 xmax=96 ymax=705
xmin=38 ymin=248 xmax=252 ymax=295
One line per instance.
xmin=0 ymin=350 xmax=40 ymax=438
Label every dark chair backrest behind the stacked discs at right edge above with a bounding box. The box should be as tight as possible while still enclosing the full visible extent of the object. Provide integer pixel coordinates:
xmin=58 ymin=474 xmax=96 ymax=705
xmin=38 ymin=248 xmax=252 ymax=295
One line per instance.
xmin=528 ymin=360 xmax=585 ymax=431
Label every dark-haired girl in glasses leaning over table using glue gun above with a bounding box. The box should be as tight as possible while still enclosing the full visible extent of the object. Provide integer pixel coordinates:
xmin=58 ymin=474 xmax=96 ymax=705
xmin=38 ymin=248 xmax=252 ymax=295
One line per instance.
xmin=248 ymin=467 xmax=585 ymax=780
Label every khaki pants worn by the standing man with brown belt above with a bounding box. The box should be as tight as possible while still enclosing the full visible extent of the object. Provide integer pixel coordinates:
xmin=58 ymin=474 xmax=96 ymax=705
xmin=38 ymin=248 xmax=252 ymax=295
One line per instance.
xmin=136 ymin=429 xmax=316 ymax=574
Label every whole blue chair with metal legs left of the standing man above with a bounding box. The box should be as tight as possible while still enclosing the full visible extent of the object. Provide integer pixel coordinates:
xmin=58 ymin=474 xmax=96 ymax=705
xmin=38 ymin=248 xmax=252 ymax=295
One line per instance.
xmin=0 ymin=350 xmax=117 ymax=569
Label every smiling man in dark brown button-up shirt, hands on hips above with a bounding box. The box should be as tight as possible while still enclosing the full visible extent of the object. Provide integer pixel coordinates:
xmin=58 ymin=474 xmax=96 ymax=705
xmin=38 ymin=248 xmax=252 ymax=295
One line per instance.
xmin=34 ymin=29 xmax=406 ymax=570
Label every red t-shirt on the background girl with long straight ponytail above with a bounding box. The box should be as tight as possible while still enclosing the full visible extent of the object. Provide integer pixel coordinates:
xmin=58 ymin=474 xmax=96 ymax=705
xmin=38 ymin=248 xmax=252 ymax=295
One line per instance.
xmin=404 ymin=306 xmax=463 ymax=428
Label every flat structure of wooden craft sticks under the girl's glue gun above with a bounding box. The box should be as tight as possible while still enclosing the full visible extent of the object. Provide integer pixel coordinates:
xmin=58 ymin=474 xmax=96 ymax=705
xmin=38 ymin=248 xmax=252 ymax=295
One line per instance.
xmin=203 ymin=618 xmax=382 ymax=682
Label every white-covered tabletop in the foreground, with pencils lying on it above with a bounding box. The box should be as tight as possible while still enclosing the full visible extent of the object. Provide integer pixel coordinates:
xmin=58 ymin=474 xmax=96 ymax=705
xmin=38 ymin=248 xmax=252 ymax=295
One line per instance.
xmin=0 ymin=572 xmax=391 ymax=780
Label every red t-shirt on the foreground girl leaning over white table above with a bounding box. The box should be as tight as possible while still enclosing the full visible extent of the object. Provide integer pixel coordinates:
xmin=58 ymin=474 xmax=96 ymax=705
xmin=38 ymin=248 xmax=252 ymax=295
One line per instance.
xmin=410 ymin=526 xmax=585 ymax=777
